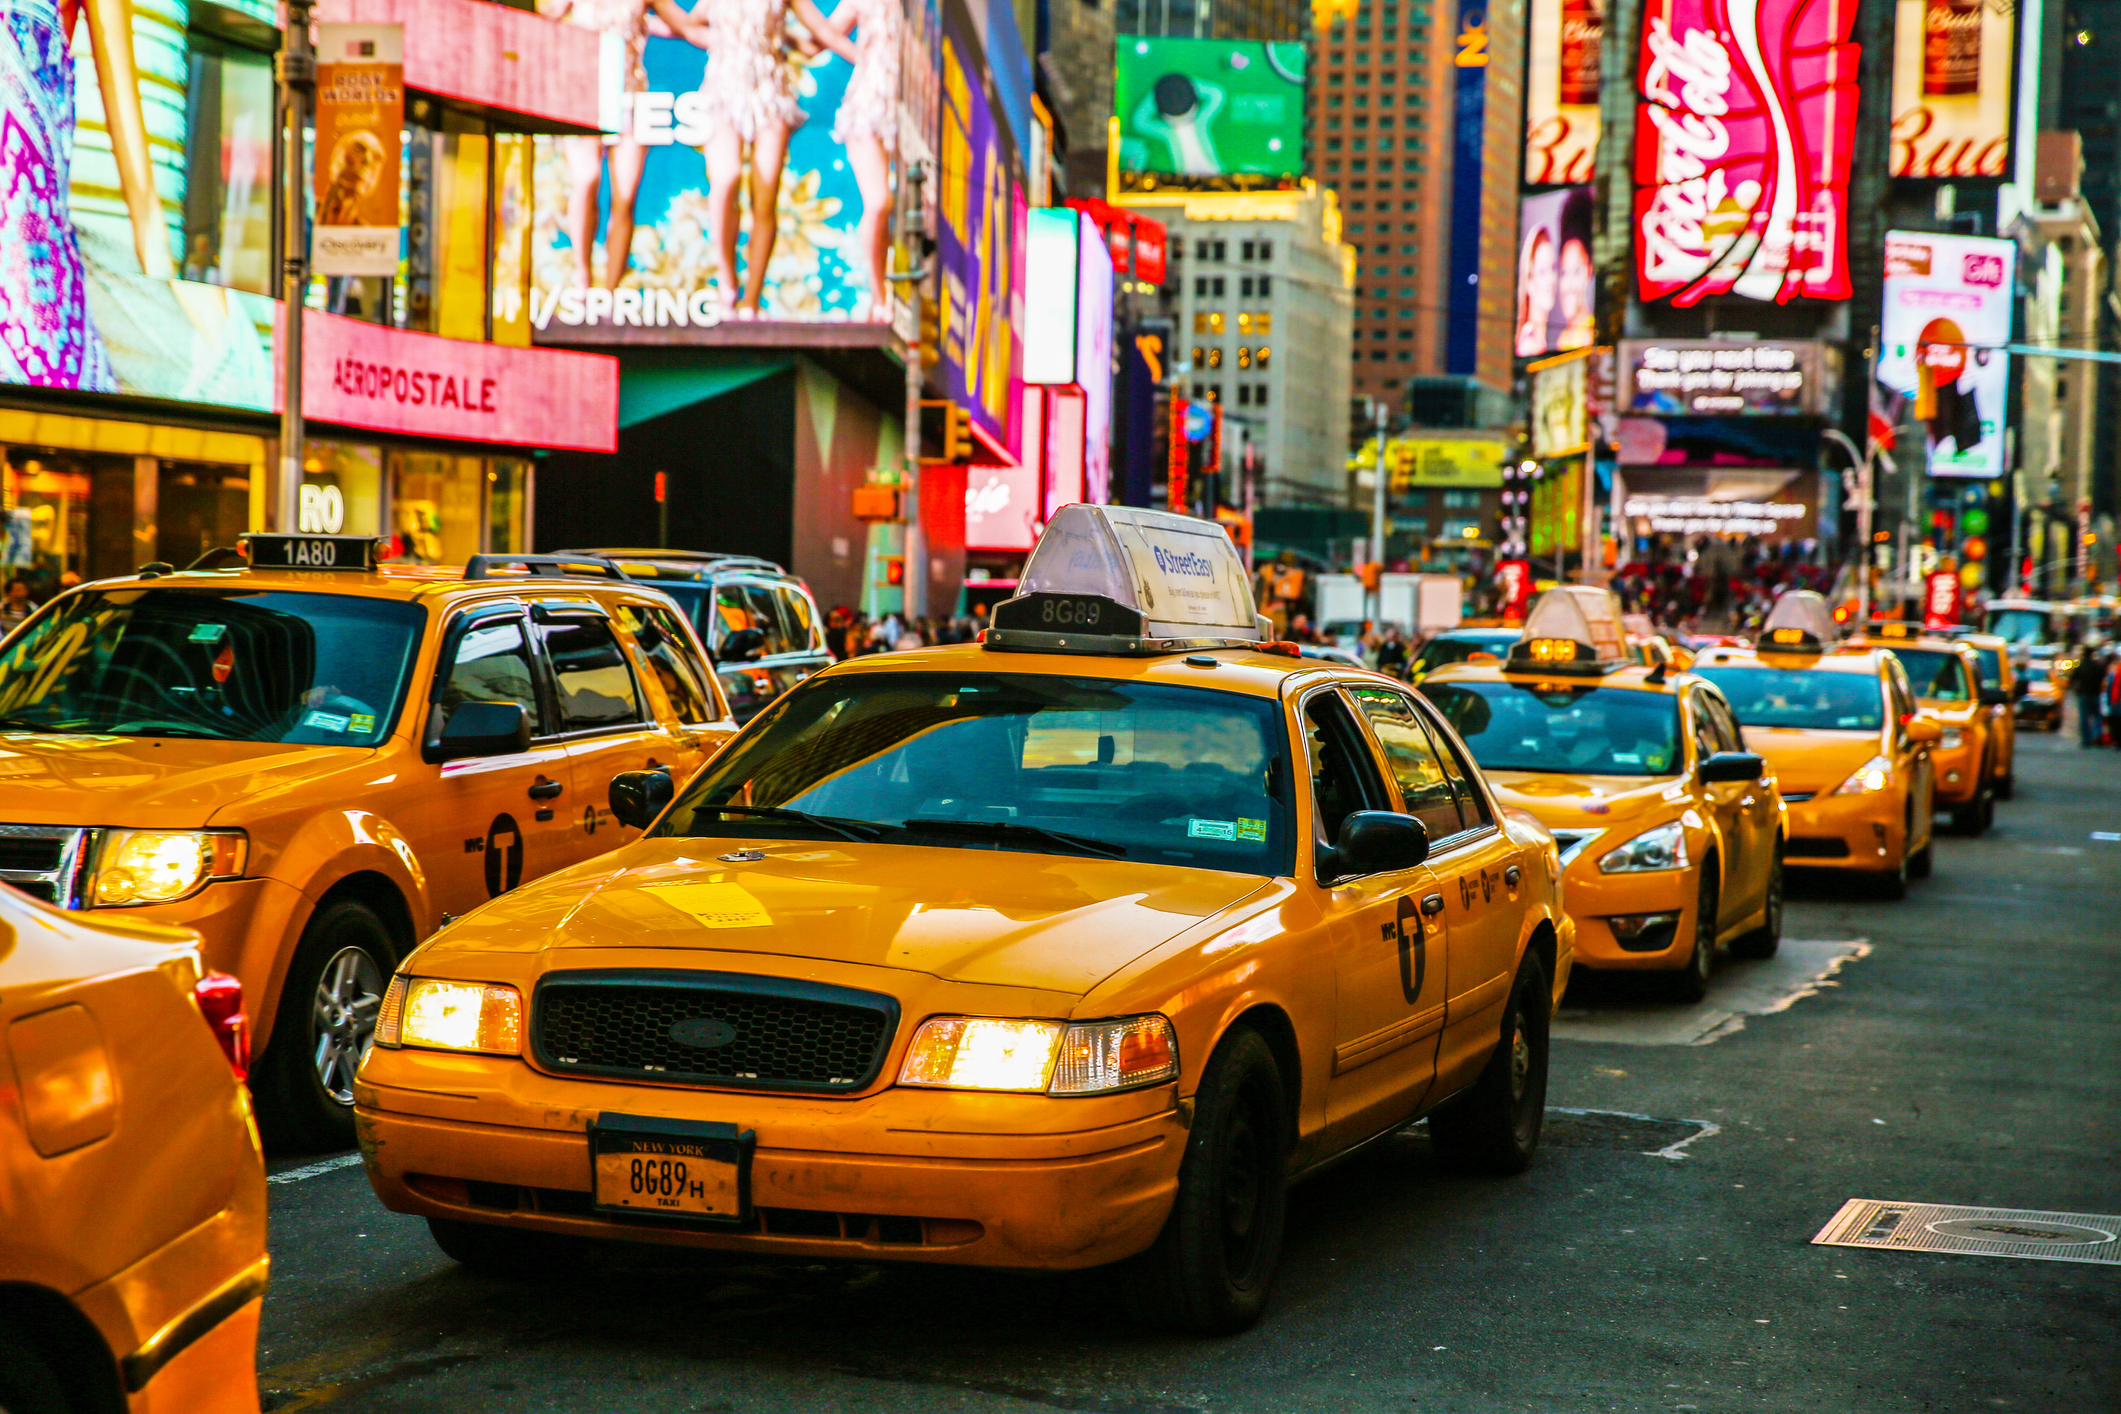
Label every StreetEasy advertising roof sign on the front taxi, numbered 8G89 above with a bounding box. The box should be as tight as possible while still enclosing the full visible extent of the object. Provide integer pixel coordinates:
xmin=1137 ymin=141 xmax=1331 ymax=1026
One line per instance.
xmin=982 ymin=505 xmax=1268 ymax=653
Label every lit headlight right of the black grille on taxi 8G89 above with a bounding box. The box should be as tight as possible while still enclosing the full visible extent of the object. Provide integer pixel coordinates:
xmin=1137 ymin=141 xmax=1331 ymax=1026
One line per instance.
xmin=899 ymin=1015 xmax=1179 ymax=1094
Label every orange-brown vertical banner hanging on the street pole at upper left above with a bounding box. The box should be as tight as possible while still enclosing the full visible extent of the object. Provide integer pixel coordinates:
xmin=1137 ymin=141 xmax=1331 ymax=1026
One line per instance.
xmin=310 ymin=25 xmax=405 ymax=276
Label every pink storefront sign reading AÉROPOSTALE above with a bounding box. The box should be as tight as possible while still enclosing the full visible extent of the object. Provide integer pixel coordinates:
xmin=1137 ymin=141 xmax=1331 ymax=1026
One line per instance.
xmin=274 ymin=310 xmax=619 ymax=452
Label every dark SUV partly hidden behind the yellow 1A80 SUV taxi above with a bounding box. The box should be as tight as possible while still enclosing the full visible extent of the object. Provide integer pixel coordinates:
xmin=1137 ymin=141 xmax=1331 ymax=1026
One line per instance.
xmin=560 ymin=549 xmax=831 ymax=723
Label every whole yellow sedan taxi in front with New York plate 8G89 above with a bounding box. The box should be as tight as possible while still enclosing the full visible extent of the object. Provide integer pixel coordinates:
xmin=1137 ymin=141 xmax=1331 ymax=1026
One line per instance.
xmin=356 ymin=507 xmax=1574 ymax=1331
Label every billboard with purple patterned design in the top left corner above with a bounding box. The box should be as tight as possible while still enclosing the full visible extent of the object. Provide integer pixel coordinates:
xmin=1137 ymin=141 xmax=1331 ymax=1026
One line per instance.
xmin=0 ymin=4 xmax=276 ymax=411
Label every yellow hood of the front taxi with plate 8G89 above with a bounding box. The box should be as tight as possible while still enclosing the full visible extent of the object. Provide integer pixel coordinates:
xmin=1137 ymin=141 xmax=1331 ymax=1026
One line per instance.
xmin=445 ymin=839 xmax=1270 ymax=994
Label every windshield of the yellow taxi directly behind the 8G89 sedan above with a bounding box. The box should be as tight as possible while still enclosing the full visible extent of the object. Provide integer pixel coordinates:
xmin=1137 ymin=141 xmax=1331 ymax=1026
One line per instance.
xmin=1421 ymin=683 xmax=1680 ymax=776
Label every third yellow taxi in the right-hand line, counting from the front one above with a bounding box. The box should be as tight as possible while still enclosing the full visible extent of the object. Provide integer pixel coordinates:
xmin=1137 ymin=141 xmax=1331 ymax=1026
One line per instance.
xmin=1693 ymin=589 xmax=1943 ymax=897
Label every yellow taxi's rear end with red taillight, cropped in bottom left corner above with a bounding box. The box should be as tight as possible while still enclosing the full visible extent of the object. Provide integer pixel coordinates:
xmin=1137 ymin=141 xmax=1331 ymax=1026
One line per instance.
xmin=0 ymin=888 xmax=267 ymax=1414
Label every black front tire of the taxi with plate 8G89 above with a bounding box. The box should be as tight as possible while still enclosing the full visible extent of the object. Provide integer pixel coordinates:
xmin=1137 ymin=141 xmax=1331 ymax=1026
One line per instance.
xmin=1122 ymin=1026 xmax=1294 ymax=1336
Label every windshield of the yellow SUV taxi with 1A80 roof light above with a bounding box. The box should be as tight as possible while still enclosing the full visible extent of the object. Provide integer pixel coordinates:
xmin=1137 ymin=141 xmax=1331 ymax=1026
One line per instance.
xmin=0 ymin=587 xmax=426 ymax=746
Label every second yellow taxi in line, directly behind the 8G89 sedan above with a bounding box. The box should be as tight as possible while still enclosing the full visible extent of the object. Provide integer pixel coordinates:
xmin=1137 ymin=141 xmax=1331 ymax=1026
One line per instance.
xmin=1421 ymin=585 xmax=1786 ymax=1001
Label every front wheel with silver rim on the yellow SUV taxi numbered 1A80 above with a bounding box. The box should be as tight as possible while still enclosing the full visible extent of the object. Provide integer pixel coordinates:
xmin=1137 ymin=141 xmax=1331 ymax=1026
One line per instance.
xmin=250 ymin=899 xmax=397 ymax=1153
